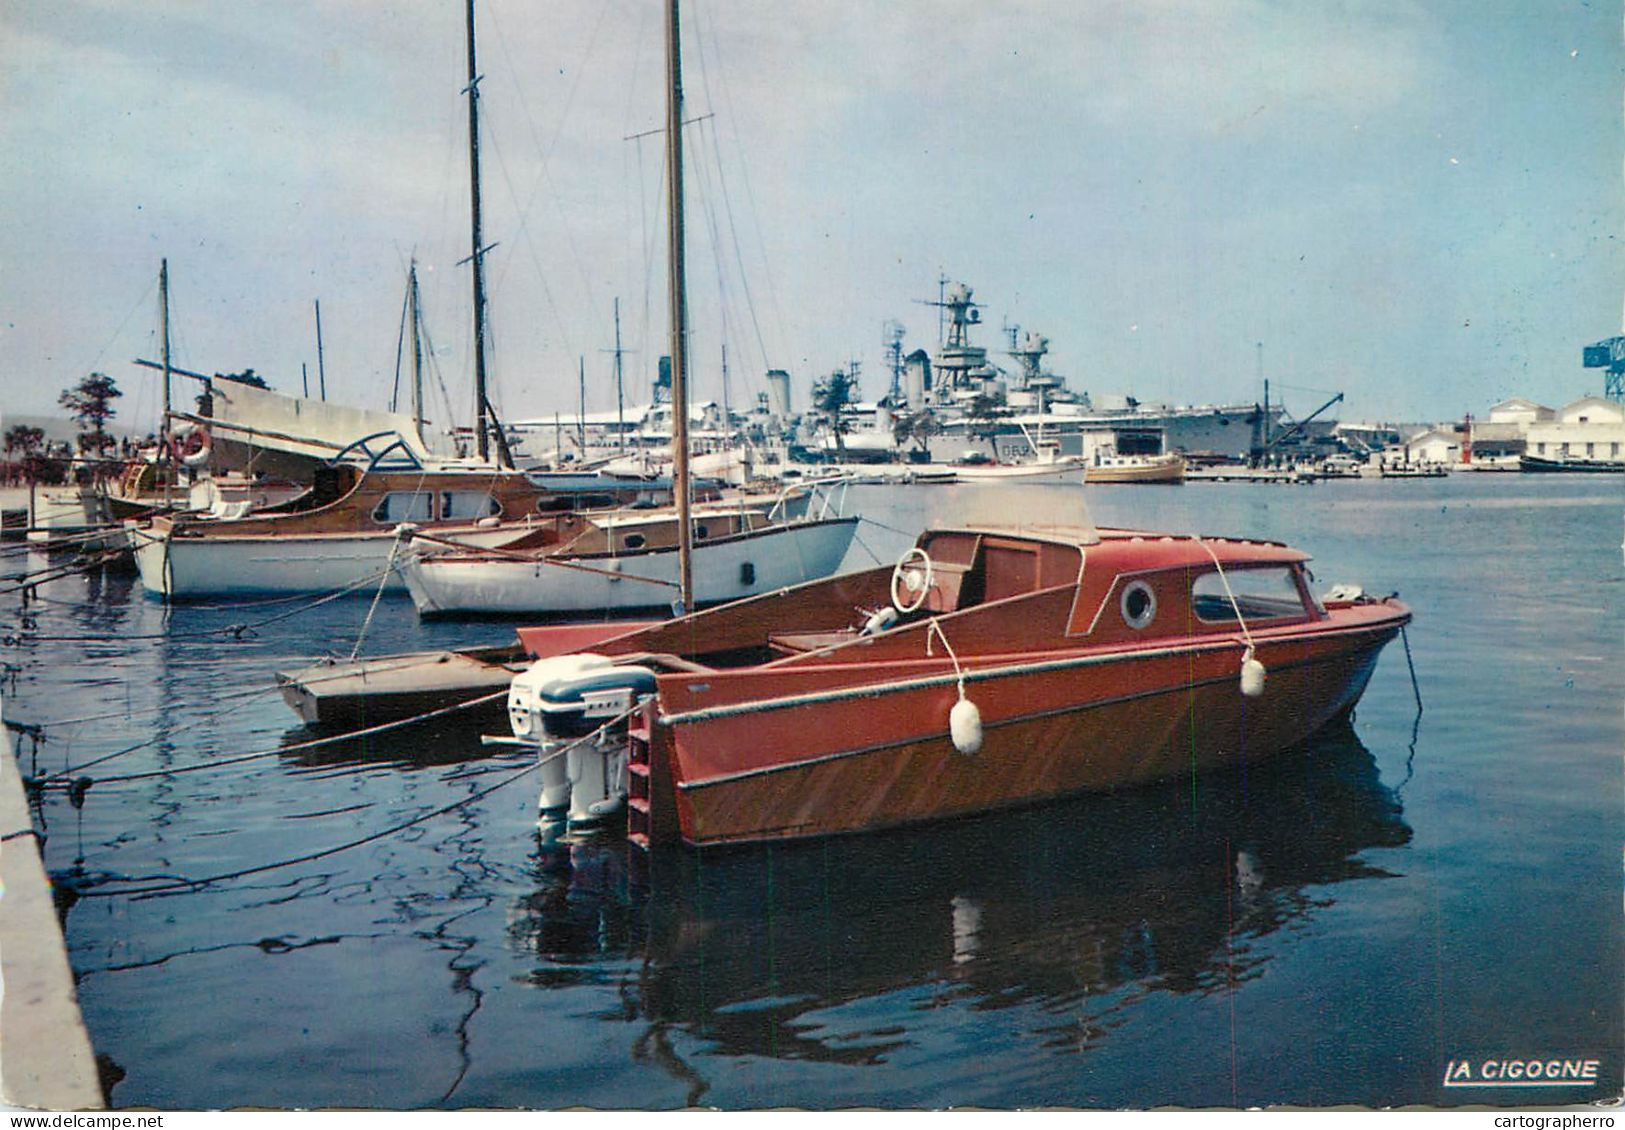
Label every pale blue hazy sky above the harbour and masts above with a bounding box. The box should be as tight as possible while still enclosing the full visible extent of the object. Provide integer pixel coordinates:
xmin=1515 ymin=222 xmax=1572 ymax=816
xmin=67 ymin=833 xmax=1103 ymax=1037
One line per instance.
xmin=0 ymin=0 xmax=1625 ymax=438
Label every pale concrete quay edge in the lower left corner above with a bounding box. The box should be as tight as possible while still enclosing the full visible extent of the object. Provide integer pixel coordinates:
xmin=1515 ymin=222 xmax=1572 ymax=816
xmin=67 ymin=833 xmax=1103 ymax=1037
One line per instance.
xmin=0 ymin=698 xmax=106 ymax=1110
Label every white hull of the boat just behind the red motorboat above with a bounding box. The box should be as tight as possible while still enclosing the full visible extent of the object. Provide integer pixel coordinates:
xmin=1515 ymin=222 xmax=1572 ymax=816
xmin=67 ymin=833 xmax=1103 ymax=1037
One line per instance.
xmin=401 ymin=517 xmax=858 ymax=618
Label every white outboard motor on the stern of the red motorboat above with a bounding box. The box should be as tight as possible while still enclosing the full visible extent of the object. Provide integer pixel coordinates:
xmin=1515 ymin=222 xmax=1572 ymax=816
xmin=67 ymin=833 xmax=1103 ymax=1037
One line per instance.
xmin=509 ymin=654 xmax=655 ymax=823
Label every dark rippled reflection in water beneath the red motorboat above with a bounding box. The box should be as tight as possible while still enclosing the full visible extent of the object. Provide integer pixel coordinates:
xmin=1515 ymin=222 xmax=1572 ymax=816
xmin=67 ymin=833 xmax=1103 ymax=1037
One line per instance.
xmin=509 ymin=722 xmax=1411 ymax=1097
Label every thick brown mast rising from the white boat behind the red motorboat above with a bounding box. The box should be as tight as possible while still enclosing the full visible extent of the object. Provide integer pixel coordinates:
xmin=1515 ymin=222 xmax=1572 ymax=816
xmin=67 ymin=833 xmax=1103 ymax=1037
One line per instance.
xmin=666 ymin=0 xmax=694 ymax=613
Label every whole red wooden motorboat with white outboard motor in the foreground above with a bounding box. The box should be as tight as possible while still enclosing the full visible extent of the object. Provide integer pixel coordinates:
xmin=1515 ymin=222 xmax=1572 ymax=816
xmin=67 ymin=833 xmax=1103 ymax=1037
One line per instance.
xmin=510 ymin=504 xmax=1411 ymax=845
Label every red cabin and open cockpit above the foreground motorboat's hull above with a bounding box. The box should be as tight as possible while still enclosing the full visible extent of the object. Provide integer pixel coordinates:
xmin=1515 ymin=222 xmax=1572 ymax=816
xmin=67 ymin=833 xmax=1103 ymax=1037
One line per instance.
xmin=527 ymin=527 xmax=1326 ymax=670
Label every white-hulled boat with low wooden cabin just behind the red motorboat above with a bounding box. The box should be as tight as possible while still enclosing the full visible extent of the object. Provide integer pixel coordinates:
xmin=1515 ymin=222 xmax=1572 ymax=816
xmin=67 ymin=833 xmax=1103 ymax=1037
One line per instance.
xmin=401 ymin=494 xmax=858 ymax=618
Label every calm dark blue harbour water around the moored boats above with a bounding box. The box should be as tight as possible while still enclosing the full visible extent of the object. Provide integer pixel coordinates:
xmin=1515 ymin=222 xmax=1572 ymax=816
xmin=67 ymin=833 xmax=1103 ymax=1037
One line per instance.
xmin=0 ymin=475 xmax=1625 ymax=1109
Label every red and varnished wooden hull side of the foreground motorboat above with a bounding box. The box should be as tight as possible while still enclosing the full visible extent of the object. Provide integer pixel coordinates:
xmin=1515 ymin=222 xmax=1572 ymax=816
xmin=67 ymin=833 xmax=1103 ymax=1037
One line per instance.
xmin=648 ymin=605 xmax=1409 ymax=845
